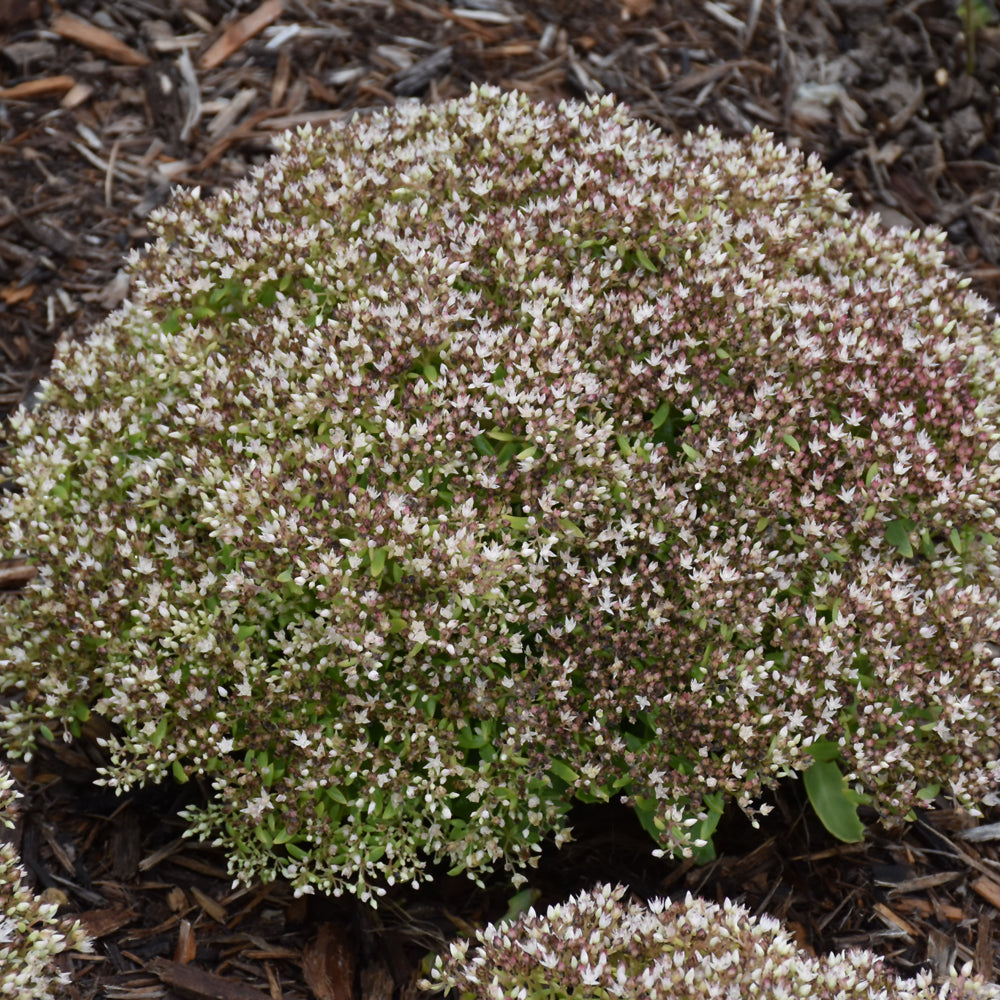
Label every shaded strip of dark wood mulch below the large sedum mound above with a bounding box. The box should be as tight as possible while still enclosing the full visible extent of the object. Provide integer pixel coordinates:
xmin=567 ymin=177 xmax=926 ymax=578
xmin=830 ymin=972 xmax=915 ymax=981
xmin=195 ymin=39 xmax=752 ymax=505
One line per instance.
xmin=12 ymin=728 xmax=1000 ymax=1000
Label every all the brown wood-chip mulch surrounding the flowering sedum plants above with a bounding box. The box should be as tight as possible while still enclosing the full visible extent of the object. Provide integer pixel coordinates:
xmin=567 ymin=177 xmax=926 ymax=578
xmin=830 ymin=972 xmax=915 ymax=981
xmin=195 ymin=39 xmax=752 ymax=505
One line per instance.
xmin=0 ymin=0 xmax=1000 ymax=1000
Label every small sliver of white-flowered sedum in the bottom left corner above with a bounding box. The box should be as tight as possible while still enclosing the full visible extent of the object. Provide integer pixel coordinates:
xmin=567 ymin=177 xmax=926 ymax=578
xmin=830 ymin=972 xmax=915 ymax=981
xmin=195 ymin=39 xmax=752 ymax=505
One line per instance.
xmin=0 ymin=765 xmax=93 ymax=1000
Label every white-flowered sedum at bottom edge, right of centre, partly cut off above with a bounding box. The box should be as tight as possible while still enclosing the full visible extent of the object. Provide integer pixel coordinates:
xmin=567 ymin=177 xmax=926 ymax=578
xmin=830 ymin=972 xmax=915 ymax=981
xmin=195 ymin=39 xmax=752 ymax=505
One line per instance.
xmin=421 ymin=885 xmax=1000 ymax=1000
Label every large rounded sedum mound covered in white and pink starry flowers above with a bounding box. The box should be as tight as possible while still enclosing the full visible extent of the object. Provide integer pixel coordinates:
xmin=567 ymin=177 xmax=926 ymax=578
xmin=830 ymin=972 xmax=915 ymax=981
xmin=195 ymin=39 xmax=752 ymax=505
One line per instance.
xmin=0 ymin=89 xmax=1000 ymax=898
